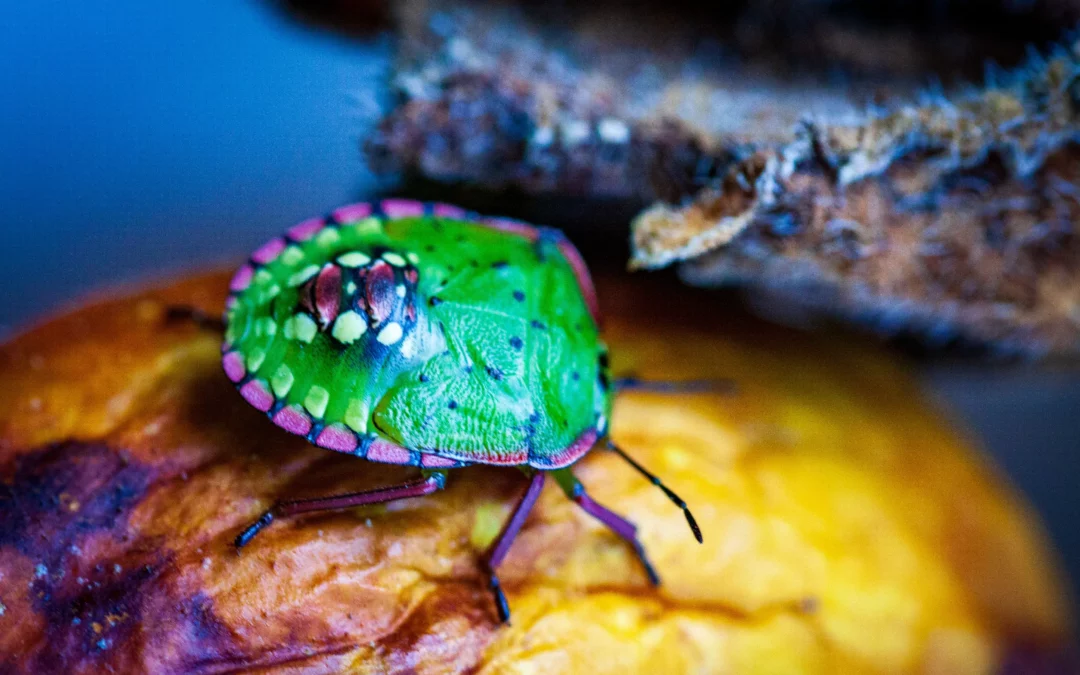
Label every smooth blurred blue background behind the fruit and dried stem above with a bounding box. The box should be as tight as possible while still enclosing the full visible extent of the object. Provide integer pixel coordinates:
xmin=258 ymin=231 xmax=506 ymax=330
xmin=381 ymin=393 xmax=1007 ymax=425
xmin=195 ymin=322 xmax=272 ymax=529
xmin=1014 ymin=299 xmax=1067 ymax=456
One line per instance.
xmin=0 ymin=0 xmax=1080 ymax=596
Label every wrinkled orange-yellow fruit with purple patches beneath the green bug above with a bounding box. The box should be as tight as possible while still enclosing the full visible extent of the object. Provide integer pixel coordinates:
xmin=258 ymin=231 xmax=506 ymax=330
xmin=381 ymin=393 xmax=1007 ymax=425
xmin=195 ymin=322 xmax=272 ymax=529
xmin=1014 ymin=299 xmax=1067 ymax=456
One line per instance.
xmin=0 ymin=274 xmax=1070 ymax=675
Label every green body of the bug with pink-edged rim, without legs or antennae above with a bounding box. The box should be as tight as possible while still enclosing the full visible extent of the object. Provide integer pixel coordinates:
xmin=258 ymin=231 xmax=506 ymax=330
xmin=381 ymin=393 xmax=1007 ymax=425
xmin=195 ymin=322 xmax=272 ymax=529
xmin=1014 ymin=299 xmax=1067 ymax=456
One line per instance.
xmin=222 ymin=200 xmax=611 ymax=469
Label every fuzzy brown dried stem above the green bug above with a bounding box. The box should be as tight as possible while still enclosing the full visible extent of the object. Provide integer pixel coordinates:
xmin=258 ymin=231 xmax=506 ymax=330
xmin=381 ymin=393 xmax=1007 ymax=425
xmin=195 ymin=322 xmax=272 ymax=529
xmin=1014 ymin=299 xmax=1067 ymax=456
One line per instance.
xmin=367 ymin=0 xmax=1080 ymax=354
